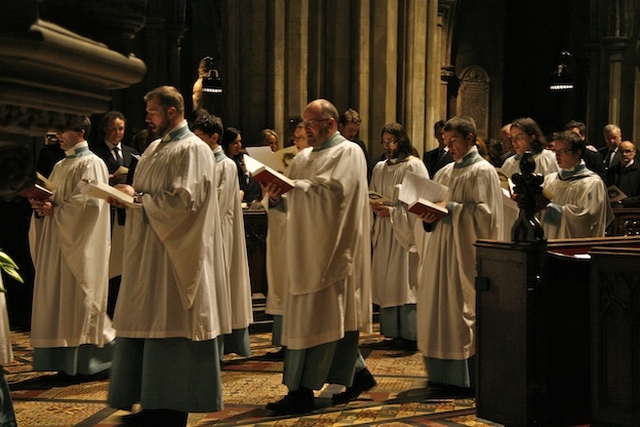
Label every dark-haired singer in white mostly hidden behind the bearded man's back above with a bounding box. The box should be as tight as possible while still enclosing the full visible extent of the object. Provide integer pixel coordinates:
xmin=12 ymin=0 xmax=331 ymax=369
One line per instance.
xmin=192 ymin=116 xmax=253 ymax=357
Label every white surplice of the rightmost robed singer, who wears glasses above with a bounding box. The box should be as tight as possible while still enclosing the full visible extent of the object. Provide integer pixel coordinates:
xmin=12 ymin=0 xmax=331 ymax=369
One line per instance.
xmin=541 ymin=161 xmax=613 ymax=239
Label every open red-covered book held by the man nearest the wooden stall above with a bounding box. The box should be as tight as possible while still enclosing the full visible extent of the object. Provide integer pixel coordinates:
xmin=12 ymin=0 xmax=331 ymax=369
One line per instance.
xmin=398 ymin=171 xmax=449 ymax=220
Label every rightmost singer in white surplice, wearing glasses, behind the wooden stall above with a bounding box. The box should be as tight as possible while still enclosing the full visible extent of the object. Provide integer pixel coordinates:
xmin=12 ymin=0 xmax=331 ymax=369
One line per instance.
xmin=541 ymin=131 xmax=613 ymax=239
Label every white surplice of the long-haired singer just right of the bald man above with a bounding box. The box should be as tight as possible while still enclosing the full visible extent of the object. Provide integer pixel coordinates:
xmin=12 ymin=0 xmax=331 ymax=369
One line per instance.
xmin=369 ymin=156 xmax=429 ymax=308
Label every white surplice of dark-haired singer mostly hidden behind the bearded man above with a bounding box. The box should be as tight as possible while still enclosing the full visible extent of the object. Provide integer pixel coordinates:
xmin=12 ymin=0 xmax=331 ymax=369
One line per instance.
xmin=213 ymin=147 xmax=253 ymax=329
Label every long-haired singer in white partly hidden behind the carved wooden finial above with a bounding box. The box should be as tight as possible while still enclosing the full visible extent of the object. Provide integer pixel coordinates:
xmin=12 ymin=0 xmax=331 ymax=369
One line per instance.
xmin=500 ymin=117 xmax=558 ymax=241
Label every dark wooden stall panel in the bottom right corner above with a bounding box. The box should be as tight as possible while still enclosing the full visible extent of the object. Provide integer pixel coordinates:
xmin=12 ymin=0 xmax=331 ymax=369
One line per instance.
xmin=591 ymin=248 xmax=640 ymax=426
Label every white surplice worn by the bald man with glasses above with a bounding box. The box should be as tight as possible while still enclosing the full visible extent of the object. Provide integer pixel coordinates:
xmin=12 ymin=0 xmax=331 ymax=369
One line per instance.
xmin=269 ymin=133 xmax=371 ymax=350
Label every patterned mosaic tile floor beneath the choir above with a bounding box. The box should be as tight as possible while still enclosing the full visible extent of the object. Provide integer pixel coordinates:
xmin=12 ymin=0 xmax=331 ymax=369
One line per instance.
xmin=4 ymin=333 xmax=499 ymax=427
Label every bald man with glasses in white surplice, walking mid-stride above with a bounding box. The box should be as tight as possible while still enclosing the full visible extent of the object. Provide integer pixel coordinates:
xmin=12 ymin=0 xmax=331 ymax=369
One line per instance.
xmin=264 ymin=99 xmax=375 ymax=414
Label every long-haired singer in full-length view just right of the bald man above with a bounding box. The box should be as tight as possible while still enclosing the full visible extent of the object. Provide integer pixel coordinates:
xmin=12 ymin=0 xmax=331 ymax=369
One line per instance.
xmin=369 ymin=123 xmax=429 ymax=351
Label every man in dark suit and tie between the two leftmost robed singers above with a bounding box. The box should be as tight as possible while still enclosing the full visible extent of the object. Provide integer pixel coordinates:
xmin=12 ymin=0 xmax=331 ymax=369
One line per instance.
xmin=91 ymin=111 xmax=138 ymax=317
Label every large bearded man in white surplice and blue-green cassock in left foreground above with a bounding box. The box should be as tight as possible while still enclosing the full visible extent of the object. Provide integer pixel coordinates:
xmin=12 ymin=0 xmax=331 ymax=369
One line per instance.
xmin=109 ymin=86 xmax=231 ymax=427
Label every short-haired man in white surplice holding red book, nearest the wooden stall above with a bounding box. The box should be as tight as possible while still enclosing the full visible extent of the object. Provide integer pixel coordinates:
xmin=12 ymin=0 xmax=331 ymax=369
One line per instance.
xmin=417 ymin=117 xmax=503 ymax=395
